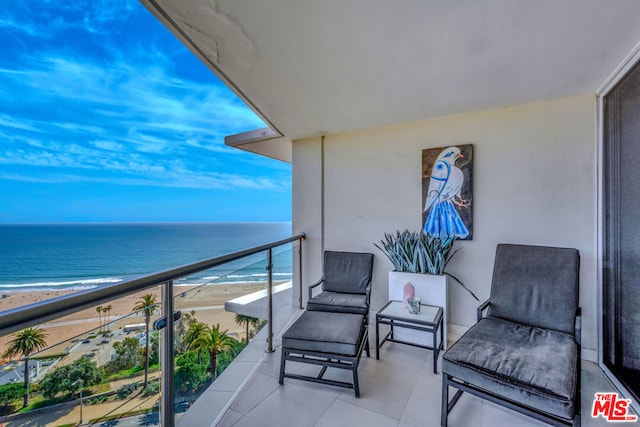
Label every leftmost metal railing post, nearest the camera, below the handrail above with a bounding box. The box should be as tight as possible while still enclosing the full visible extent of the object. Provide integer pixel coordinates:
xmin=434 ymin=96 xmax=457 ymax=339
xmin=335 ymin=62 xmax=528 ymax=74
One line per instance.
xmin=160 ymin=280 xmax=175 ymax=427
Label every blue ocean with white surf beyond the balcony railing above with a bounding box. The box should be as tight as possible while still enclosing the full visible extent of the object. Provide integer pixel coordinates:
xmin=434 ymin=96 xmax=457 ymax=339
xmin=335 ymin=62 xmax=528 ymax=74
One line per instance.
xmin=0 ymin=223 xmax=292 ymax=293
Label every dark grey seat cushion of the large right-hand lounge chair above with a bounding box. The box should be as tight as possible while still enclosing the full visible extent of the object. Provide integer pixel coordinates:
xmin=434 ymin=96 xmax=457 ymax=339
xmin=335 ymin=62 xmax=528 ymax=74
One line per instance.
xmin=442 ymin=318 xmax=578 ymax=419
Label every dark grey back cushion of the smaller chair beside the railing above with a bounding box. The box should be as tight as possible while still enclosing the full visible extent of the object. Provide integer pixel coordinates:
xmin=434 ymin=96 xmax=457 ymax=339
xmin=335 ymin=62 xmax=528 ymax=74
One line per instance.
xmin=322 ymin=251 xmax=373 ymax=294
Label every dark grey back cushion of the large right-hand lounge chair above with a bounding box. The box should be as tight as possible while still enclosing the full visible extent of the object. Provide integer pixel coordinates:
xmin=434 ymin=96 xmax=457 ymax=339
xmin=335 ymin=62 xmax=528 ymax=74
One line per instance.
xmin=488 ymin=244 xmax=580 ymax=334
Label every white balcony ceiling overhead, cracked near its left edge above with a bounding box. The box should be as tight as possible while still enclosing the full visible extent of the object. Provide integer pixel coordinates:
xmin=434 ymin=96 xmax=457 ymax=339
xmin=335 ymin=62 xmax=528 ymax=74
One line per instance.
xmin=141 ymin=0 xmax=640 ymax=145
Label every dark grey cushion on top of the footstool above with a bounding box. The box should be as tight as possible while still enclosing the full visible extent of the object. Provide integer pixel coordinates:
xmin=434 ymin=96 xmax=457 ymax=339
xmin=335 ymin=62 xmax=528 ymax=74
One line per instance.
xmin=282 ymin=311 xmax=364 ymax=356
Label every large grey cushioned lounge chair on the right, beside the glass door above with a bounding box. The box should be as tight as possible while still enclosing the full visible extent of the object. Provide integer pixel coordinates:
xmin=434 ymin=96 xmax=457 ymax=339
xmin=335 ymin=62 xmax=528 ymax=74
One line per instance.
xmin=441 ymin=244 xmax=580 ymax=427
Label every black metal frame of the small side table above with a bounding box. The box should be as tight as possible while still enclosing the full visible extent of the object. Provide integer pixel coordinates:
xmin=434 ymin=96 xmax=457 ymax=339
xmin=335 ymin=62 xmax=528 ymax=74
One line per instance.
xmin=376 ymin=300 xmax=444 ymax=374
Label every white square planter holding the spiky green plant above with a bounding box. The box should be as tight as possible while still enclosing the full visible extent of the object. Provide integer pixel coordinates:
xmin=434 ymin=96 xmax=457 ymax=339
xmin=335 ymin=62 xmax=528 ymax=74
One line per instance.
xmin=389 ymin=271 xmax=449 ymax=348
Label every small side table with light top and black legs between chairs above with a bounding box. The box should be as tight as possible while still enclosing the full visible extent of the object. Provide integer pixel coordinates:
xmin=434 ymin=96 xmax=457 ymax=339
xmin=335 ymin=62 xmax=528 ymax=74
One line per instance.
xmin=376 ymin=301 xmax=443 ymax=374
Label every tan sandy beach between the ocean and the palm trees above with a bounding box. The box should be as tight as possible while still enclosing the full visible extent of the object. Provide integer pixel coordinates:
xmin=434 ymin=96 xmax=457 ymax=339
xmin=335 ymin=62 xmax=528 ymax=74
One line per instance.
xmin=0 ymin=283 xmax=265 ymax=362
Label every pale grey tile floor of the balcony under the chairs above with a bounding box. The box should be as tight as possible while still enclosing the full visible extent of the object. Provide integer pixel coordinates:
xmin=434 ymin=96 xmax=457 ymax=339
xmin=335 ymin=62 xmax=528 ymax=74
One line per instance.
xmin=212 ymin=316 xmax=632 ymax=427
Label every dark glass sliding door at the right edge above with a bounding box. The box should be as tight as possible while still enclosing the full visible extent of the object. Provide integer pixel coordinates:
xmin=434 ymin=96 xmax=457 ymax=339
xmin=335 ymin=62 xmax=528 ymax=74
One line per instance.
xmin=602 ymin=57 xmax=640 ymax=400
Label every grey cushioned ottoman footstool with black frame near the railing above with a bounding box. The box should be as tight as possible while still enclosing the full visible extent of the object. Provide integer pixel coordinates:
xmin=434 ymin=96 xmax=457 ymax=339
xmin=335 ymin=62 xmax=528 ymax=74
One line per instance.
xmin=280 ymin=311 xmax=369 ymax=397
